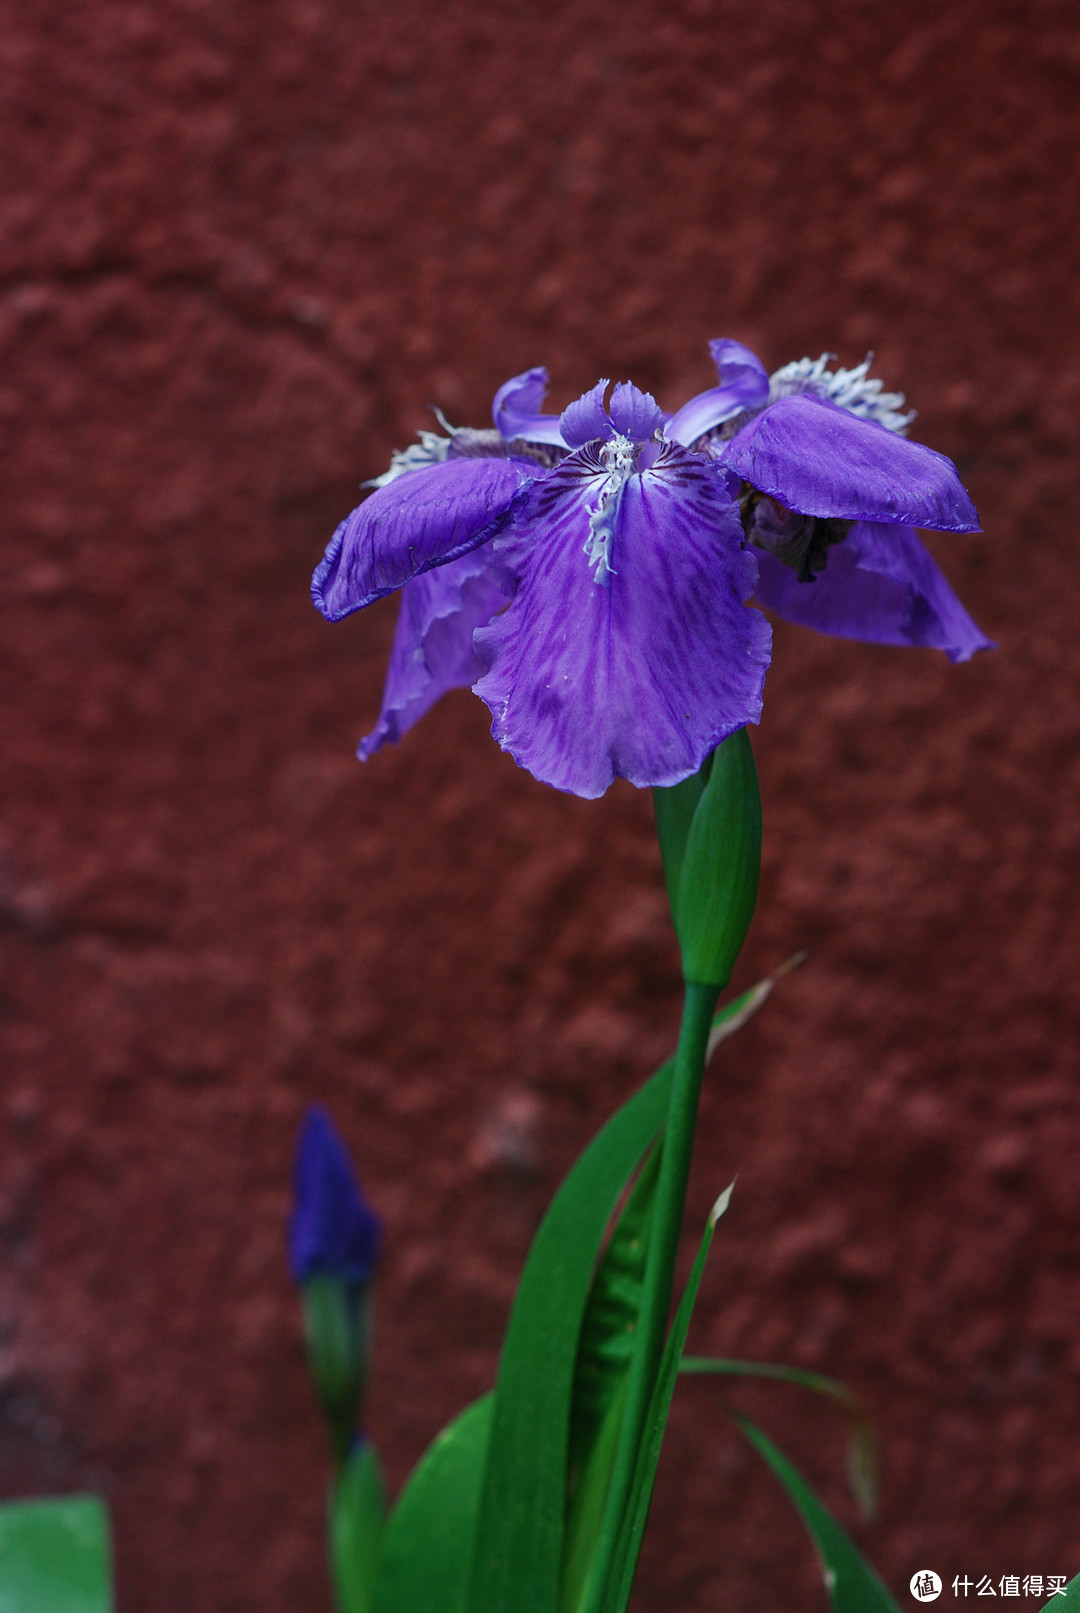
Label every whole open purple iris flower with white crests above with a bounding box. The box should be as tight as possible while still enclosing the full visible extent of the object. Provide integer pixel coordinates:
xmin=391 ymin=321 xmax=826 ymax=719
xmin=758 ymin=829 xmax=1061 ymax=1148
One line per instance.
xmin=313 ymin=342 xmax=990 ymax=797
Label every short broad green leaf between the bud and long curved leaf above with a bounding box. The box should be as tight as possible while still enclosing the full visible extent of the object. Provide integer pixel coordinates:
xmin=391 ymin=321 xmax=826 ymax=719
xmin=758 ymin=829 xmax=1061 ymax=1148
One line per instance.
xmin=374 ymin=1394 xmax=493 ymax=1613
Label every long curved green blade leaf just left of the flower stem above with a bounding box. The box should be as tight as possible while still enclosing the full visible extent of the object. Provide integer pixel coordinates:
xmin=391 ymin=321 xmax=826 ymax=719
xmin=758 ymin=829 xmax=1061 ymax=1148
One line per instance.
xmin=467 ymin=1060 xmax=672 ymax=1613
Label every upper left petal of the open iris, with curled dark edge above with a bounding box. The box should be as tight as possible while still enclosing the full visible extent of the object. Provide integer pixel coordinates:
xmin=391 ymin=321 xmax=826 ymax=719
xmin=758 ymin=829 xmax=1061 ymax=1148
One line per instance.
xmin=311 ymin=458 xmax=540 ymax=621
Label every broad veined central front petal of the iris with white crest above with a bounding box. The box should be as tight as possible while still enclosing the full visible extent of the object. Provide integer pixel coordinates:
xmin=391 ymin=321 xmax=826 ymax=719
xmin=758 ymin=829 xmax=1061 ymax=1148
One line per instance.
xmin=474 ymin=444 xmax=771 ymax=797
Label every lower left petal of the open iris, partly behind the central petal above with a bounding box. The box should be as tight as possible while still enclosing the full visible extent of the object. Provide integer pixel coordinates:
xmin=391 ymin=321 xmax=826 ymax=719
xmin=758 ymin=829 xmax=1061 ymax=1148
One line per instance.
xmin=356 ymin=544 xmax=506 ymax=761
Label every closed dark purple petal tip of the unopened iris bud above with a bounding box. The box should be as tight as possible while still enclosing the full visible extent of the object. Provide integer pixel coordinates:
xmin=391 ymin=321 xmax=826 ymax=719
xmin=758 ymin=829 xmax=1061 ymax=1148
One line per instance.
xmin=289 ymin=1105 xmax=380 ymax=1289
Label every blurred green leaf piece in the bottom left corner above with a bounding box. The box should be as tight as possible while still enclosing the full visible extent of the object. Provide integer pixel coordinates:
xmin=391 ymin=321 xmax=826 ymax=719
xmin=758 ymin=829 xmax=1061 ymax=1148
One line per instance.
xmin=0 ymin=1495 xmax=113 ymax=1613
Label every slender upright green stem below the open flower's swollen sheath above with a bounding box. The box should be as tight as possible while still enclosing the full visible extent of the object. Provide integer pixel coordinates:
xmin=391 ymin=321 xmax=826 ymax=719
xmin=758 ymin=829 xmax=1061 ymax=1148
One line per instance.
xmin=584 ymin=981 xmax=721 ymax=1613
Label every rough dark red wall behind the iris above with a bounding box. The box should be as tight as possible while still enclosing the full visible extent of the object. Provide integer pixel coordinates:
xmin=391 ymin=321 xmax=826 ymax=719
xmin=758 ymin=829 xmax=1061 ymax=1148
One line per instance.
xmin=0 ymin=0 xmax=1080 ymax=1613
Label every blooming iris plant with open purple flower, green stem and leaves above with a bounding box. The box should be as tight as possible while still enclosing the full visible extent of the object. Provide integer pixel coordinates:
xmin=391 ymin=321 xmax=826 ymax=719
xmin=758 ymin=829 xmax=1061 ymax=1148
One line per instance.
xmin=303 ymin=340 xmax=988 ymax=1613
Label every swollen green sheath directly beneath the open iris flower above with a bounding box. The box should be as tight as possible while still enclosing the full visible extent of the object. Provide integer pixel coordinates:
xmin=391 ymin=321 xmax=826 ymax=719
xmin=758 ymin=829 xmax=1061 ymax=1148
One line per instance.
xmin=674 ymin=729 xmax=761 ymax=987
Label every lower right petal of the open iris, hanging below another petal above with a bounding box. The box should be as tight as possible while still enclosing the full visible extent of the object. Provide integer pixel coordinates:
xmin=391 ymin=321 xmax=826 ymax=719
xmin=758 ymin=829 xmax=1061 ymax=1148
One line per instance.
xmin=756 ymin=521 xmax=995 ymax=661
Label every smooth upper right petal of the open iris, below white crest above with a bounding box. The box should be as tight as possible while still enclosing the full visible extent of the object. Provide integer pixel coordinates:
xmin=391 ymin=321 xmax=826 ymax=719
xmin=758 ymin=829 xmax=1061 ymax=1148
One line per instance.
xmin=717 ymin=392 xmax=978 ymax=532
